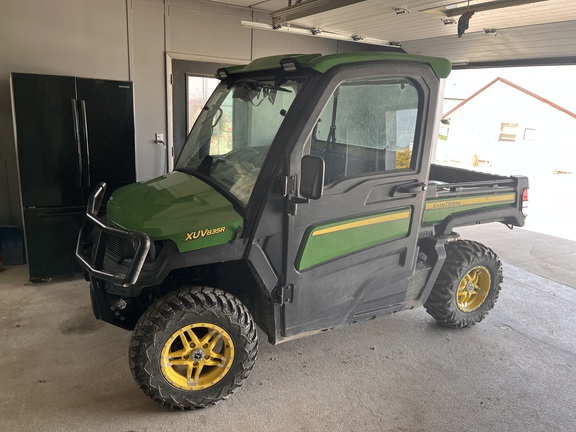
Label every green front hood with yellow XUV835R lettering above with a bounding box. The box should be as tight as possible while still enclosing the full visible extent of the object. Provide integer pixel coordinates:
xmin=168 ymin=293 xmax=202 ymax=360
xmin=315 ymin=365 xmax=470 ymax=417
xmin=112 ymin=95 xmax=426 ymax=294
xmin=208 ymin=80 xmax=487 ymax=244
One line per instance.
xmin=106 ymin=171 xmax=243 ymax=252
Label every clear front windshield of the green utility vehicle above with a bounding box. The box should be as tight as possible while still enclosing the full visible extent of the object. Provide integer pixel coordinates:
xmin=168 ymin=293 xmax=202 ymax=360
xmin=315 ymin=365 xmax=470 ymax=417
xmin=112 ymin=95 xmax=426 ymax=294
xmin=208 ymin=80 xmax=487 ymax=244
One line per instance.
xmin=176 ymin=80 xmax=301 ymax=205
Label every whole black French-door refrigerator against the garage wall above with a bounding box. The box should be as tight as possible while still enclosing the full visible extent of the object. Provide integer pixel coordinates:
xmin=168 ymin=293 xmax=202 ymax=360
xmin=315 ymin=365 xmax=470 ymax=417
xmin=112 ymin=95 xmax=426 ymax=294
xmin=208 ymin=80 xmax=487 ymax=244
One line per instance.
xmin=10 ymin=73 xmax=136 ymax=282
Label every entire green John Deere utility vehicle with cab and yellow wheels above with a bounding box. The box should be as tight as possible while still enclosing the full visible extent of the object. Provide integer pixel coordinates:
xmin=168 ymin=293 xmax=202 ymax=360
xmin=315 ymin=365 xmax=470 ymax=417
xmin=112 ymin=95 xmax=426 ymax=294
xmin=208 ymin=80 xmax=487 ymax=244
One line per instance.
xmin=77 ymin=52 xmax=528 ymax=409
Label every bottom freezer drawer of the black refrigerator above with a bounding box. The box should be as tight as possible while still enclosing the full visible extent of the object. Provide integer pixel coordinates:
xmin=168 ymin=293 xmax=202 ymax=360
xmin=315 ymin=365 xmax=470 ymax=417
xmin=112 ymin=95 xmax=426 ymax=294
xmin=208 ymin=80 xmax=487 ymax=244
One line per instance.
xmin=24 ymin=207 xmax=86 ymax=282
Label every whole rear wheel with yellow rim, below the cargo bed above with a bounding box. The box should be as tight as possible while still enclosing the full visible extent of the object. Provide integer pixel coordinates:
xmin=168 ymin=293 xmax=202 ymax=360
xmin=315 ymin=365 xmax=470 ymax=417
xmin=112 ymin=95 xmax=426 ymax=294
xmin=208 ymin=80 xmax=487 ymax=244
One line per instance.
xmin=424 ymin=240 xmax=502 ymax=328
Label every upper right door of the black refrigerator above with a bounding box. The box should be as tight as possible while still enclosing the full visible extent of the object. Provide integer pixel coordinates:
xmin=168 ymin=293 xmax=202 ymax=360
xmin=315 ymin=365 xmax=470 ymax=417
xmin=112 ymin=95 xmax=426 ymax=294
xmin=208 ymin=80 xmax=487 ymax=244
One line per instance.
xmin=77 ymin=78 xmax=136 ymax=196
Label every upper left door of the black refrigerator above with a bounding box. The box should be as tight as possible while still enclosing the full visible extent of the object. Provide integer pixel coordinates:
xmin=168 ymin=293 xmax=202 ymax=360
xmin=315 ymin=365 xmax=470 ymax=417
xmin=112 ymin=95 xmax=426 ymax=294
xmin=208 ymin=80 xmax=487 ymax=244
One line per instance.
xmin=12 ymin=73 xmax=83 ymax=208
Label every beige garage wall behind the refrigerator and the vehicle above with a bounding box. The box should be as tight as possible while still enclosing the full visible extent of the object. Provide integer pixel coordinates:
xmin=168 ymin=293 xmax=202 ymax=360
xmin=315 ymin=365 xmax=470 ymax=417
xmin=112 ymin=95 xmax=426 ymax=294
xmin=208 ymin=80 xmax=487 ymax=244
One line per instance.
xmin=0 ymin=0 xmax=377 ymax=226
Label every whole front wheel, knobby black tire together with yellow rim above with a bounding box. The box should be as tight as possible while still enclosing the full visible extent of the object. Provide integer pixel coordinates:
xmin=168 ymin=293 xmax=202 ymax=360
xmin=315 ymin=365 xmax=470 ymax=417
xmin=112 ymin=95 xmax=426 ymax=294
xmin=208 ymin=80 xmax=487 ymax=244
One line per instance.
xmin=129 ymin=287 xmax=258 ymax=410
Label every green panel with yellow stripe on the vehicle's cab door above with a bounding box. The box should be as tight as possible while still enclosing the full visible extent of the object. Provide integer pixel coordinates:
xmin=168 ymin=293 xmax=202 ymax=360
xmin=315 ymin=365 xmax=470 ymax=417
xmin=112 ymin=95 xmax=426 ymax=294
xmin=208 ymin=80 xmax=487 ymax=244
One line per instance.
xmin=295 ymin=207 xmax=412 ymax=271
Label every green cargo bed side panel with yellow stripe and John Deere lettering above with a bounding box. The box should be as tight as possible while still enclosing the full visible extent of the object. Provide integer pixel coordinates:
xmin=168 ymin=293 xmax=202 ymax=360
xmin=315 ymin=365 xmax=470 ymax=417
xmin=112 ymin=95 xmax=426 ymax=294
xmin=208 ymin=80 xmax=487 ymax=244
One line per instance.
xmin=422 ymin=193 xmax=516 ymax=224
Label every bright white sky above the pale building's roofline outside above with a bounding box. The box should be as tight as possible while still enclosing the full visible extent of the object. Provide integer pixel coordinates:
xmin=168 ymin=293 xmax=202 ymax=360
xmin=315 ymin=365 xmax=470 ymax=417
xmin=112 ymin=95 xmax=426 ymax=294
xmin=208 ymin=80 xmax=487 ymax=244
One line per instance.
xmin=444 ymin=66 xmax=576 ymax=113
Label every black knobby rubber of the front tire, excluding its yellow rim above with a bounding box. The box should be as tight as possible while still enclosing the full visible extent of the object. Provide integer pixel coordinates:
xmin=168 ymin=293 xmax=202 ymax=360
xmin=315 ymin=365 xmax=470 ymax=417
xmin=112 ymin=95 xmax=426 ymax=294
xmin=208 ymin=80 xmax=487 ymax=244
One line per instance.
xmin=129 ymin=287 xmax=258 ymax=410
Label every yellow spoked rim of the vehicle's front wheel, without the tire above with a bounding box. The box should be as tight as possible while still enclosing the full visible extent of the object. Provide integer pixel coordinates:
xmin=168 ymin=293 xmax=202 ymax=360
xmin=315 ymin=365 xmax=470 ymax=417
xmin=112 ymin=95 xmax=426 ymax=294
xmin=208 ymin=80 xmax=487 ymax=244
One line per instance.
xmin=160 ymin=323 xmax=234 ymax=390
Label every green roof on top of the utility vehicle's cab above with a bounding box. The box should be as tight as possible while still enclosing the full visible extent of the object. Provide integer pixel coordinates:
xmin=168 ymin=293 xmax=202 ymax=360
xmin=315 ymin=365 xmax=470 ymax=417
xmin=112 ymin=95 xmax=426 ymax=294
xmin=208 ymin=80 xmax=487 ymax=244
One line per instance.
xmin=219 ymin=52 xmax=452 ymax=78
